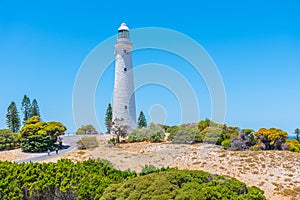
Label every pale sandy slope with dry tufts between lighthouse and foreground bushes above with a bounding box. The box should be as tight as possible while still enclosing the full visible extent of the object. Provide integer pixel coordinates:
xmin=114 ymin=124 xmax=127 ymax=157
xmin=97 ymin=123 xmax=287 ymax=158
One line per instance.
xmin=0 ymin=135 xmax=300 ymax=200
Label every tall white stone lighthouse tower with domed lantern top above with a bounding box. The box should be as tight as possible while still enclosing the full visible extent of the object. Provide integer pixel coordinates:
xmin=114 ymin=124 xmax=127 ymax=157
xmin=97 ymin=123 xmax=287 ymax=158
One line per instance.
xmin=113 ymin=23 xmax=136 ymax=128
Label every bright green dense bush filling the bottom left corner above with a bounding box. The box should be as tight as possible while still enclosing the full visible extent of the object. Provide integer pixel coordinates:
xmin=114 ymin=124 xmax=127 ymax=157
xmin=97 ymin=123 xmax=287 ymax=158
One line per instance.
xmin=0 ymin=159 xmax=136 ymax=200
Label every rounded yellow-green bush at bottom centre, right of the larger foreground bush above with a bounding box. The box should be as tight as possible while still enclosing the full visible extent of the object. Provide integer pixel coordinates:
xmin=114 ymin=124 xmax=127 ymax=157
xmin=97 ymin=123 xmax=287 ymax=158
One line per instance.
xmin=101 ymin=167 xmax=266 ymax=200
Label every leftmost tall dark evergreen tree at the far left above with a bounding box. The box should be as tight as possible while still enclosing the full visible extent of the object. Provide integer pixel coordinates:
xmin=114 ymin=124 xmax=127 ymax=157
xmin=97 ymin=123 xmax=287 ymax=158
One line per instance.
xmin=6 ymin=101 xmax=21 ymax=132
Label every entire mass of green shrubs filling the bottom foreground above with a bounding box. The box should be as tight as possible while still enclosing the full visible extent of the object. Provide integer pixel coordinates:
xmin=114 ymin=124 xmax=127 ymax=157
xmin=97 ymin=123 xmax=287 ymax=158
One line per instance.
xmin=0 ymin=159 xmax=265 ymax=200
